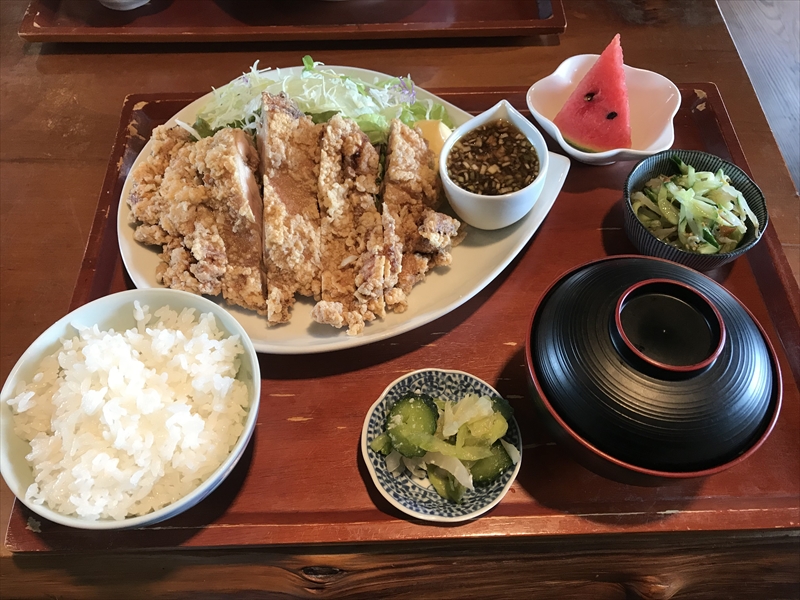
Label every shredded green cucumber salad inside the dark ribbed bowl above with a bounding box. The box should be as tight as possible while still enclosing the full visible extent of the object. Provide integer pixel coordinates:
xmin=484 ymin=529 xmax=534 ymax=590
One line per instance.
xmin=631 ymin=157 xmax=759 ymax=254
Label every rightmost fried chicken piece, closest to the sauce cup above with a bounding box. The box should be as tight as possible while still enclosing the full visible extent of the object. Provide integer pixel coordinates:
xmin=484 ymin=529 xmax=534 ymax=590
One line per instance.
xmin=382 ymin=119 xmax=460 ymax=312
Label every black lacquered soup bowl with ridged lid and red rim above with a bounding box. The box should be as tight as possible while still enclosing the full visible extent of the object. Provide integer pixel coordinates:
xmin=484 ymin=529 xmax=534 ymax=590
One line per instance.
xmin=526 ymin=256 xmax=782 ymax=485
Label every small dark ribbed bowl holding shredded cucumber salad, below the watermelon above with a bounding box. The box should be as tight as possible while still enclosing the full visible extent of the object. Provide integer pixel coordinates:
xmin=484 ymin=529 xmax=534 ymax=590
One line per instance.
xmin=622 ymin=150 xmax=769 ymax=271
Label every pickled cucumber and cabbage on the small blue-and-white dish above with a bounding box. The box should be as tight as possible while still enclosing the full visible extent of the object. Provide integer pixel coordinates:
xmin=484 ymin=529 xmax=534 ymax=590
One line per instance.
xmin=370 ymin=393 xmax=520 ymax=503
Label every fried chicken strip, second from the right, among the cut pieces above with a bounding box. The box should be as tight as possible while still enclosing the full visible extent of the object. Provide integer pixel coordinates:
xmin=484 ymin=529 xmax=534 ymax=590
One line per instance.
xmin=312 ymin=115 xmax=386 ymax=335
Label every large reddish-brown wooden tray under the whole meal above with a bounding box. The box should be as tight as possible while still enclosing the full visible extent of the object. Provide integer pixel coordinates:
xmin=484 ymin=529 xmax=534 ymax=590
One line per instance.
xmin=6 ymin=83 xmax=800 ymax=552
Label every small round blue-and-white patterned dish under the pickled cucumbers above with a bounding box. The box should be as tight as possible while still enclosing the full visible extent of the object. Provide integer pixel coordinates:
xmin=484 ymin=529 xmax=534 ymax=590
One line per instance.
xmin=361 ymin=369 xmax=522 ymax=523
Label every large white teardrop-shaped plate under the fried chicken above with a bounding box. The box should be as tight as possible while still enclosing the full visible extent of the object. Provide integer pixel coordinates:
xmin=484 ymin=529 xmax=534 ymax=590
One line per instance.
xmin=117 ymin=65 xmax=570 ymax=354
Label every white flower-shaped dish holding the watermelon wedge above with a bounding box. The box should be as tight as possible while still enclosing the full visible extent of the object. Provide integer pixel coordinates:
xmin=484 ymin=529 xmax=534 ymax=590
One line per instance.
xmin=527 ymin=54 xmax=681 ymax=165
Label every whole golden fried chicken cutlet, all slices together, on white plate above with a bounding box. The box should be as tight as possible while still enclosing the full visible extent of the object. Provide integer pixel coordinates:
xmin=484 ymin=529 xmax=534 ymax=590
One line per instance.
xmin=128 ymin=108 xmax=463 ymax=335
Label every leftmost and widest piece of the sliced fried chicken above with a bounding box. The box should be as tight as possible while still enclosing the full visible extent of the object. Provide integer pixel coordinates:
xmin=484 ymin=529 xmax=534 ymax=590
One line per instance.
xmin=128 ymin=126 xmax=266 ymax=313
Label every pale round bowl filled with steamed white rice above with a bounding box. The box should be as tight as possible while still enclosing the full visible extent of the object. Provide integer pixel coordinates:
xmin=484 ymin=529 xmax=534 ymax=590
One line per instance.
xmin=0 ymin=289 xmax=261 ymax=529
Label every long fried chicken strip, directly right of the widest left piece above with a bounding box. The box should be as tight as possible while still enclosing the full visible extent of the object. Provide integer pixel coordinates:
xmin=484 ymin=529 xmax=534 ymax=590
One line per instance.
xmin=258 ymin=93 xmax=323 ymax=325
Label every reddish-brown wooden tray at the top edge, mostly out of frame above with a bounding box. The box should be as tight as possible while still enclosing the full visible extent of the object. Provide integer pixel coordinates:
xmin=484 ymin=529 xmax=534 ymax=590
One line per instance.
xmin=19 ymin=0 xmax=567 ymax=42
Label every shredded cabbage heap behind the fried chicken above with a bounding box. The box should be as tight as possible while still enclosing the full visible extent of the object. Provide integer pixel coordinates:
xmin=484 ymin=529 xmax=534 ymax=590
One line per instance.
xmin=194 ymin=56 xmax=453 ymax=144
